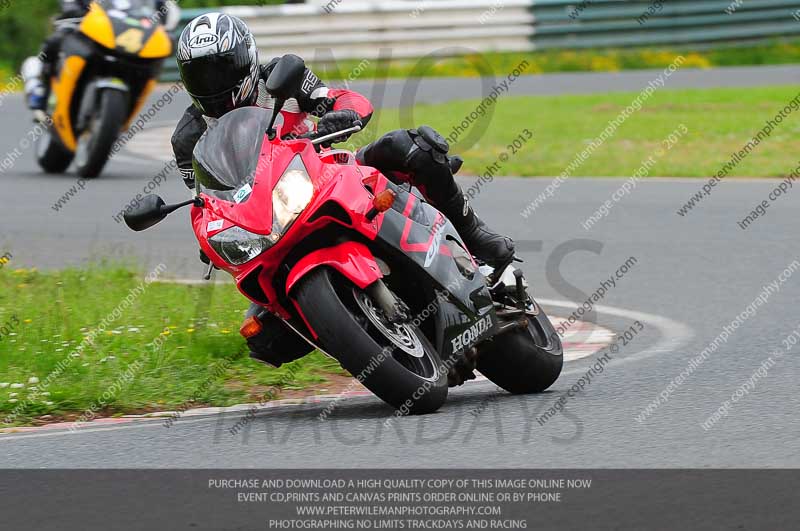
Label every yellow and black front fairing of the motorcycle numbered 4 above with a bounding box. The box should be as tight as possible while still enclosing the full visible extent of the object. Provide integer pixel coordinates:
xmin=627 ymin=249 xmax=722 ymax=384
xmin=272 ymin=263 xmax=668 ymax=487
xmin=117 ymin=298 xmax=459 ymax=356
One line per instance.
xmin=52 ymin=0 xmax=172 ymax=151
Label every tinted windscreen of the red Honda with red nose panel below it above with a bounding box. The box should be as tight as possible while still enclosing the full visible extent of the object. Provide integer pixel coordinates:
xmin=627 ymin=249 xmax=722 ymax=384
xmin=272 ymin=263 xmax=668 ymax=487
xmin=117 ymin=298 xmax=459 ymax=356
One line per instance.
xmin=192 ymin=107 xmax=272 ymax=233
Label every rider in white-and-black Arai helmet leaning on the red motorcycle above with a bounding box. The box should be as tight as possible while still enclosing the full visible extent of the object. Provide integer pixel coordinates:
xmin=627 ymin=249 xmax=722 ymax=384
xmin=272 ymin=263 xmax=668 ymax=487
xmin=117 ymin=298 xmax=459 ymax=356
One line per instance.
xmin=172 ymin=13 xmax=514 ymax=268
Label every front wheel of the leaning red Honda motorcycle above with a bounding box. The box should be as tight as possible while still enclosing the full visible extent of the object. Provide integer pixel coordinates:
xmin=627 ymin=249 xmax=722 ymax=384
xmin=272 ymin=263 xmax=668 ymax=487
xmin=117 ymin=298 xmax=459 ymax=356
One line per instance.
xmin=296 ymin=267 xmax=447 ymax=414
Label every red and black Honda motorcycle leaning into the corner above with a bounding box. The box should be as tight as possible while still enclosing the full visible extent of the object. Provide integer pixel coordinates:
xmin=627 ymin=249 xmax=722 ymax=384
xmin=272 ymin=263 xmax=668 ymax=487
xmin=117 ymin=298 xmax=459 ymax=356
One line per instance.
xmin=125 ymin=56 xmax=563 ymax=413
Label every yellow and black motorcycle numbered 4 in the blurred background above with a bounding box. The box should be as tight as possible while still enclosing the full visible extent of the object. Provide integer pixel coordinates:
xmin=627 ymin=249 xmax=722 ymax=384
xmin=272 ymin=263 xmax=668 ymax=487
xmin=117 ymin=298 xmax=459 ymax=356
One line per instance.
xmin=36 ymin=0 xmax=172 ymax=178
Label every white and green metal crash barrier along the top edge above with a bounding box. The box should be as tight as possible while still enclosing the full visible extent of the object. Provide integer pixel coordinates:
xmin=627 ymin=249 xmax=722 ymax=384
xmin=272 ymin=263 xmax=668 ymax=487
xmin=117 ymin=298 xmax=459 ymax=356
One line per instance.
xmin=159 ymin=0 xmax=800 ymax=79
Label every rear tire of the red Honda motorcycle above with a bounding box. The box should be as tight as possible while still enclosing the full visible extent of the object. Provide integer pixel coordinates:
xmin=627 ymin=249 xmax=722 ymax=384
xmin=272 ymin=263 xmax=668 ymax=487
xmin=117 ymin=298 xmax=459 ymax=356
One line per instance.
xmin=478 ymin=308 xmax=564 ymax=395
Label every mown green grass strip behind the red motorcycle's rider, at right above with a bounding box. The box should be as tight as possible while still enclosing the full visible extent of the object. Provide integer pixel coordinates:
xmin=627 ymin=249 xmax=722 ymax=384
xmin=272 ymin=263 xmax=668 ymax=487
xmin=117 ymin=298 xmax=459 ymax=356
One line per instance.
xmin=355 ymin=87 xmax=800 ymax=177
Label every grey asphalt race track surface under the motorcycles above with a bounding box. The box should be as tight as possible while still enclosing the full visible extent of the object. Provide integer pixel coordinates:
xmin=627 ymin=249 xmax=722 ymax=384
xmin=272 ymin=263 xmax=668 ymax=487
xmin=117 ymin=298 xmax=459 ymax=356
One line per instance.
xmin=0 ymin=68 xmax=800 ymax=470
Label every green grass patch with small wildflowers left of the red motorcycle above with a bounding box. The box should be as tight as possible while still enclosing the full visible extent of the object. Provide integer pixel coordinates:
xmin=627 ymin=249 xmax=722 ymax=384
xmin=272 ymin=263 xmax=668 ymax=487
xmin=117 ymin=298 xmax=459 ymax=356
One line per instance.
xmin=0 ymin=265 xmax=342 ymax=424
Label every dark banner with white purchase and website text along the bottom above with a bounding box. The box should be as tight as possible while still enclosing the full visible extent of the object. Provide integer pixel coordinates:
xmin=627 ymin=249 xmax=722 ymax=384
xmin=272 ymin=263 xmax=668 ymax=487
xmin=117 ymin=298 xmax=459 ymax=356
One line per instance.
xmin=0 ymin=469 xmax=800 ymax=531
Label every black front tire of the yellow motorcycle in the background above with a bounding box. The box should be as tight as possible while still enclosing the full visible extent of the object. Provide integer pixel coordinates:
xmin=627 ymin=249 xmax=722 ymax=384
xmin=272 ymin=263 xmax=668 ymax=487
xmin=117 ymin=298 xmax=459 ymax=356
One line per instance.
xmin=75 ymin=89 xmax=128 ymax=179
